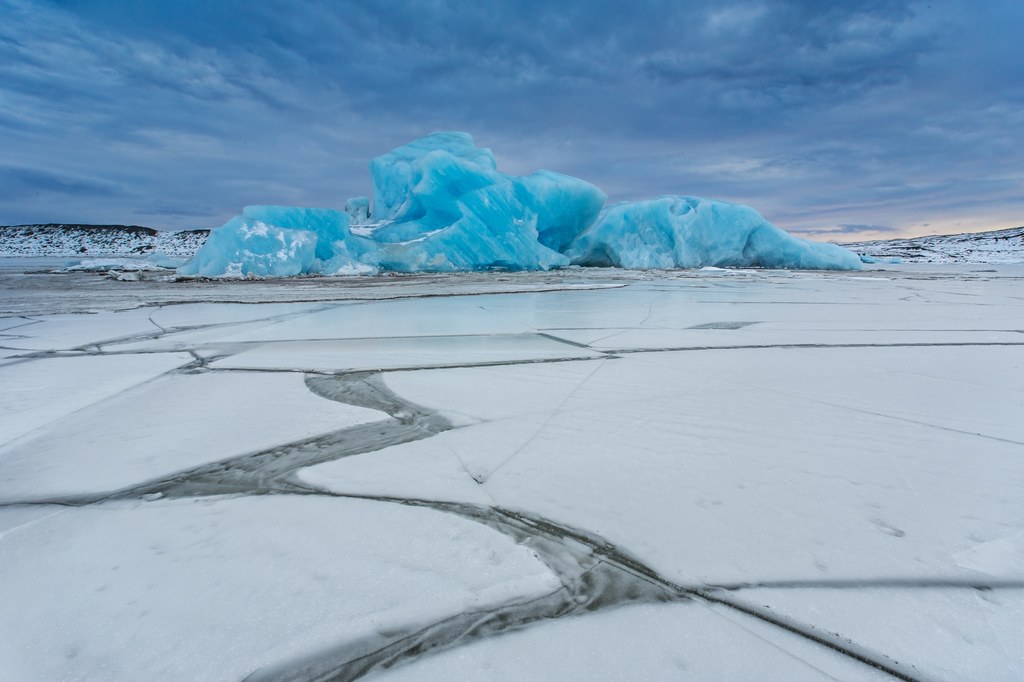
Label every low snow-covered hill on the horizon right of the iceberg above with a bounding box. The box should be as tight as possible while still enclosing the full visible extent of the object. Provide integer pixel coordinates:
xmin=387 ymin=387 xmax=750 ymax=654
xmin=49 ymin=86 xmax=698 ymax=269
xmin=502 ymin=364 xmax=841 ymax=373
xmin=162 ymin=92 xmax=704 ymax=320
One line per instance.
xmin=843 ymin=227 xmax=1024 ymax=263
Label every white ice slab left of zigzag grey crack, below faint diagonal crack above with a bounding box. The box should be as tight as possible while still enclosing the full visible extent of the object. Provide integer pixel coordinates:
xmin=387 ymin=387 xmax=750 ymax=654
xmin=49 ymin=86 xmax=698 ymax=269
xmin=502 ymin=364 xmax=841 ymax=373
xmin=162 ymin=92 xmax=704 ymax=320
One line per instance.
xmin=0 ymin=372 xmax=387 ymax=501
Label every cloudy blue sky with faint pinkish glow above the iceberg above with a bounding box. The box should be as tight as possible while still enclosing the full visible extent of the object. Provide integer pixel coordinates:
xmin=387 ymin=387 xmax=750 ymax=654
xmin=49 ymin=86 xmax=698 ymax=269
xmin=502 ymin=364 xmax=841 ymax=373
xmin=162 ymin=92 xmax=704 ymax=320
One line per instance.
xmin=0 ymin=0 xmax=1024 ymax=242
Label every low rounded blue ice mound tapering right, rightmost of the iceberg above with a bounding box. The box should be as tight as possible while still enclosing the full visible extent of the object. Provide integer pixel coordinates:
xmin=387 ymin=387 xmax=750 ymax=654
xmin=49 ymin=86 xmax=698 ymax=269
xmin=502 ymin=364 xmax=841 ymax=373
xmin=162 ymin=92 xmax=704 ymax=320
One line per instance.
xmin=565 ymin=196 xmax=860 ymax=270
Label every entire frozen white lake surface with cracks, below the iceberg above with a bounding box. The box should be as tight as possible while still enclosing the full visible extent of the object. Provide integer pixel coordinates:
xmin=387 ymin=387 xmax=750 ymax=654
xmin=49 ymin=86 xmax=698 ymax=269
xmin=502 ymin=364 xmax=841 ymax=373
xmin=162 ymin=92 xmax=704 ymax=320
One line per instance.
xmin=0 ymin=258 xmax=1024 ymax=680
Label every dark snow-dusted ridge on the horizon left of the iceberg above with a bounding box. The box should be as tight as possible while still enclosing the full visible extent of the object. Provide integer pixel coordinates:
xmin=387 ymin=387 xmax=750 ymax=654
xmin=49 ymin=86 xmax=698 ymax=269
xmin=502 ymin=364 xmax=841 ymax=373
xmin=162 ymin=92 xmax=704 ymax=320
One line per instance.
xmin=0 ymin=223 xmax=210 ymax=258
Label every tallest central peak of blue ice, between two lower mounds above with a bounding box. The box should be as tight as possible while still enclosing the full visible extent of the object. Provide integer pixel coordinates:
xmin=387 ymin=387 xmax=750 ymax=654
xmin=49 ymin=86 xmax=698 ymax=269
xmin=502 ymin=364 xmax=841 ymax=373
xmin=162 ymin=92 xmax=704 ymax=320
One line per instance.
xmin=369 ymin=132 xmax=606 ymax=272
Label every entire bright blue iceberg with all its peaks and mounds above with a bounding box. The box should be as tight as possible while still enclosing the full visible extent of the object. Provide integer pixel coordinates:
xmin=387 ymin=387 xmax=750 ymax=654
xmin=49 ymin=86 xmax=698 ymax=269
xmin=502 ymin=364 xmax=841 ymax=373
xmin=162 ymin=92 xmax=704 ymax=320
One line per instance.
xmin=178 ymin=132 xmax=860 ymax=278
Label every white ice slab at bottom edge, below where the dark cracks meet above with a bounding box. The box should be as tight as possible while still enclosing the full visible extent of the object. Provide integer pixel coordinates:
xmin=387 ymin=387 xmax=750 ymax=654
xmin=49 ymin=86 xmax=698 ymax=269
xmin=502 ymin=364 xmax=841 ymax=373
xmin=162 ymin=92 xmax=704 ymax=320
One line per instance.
xmin=367 ymin=603 xmax=892 ymax=682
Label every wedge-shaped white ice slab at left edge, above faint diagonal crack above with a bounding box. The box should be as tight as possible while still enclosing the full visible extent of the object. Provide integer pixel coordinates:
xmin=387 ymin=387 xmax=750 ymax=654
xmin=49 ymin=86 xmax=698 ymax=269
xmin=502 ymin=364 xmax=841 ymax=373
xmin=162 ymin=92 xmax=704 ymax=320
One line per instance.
xmin=0 ymin=353 xmax=194 ymax=445
